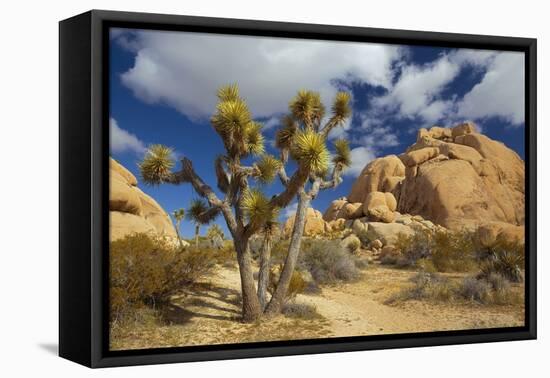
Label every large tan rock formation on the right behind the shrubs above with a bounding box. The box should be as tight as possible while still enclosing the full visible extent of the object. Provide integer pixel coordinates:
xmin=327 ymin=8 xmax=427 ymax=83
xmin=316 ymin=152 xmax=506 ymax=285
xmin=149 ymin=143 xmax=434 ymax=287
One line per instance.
xmin=324 ymin=122 xmax=525 ymax=230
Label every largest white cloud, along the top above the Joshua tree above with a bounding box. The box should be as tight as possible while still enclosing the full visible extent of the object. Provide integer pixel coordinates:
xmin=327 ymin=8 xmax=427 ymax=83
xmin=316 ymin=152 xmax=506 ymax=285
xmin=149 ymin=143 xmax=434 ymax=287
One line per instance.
xmin=119 ymin=31 xmax=404 ymax=118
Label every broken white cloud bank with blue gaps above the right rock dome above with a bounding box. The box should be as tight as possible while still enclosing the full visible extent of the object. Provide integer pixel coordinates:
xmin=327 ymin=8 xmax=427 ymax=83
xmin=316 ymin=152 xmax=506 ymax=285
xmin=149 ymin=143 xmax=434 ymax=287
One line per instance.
xmin=372 ymin=49 xmax=525 ymax=125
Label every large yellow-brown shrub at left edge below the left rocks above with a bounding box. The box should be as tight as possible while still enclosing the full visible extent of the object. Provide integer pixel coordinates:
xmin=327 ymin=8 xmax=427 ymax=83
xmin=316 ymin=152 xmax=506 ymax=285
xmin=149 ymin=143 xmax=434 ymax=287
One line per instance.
xmin=109 ymin=234 xmax=214 ymax=319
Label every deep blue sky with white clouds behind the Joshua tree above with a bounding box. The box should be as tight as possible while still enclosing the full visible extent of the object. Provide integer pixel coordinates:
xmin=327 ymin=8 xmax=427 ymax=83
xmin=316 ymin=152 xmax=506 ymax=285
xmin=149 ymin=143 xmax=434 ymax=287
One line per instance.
xmin=109 ymin=29 xmax=524 ymax=237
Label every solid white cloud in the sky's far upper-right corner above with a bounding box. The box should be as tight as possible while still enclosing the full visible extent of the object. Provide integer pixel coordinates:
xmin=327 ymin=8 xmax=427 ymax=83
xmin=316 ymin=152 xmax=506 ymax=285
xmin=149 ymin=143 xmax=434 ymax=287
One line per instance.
xmin=457 ymin=52 xmax=525 ymax=125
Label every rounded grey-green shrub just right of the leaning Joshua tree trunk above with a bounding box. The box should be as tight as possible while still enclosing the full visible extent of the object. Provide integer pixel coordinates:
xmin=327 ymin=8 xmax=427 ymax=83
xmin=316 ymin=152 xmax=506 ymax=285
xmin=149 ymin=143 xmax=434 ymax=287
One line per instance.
xmin=298 ymin=240 xmax=361 ymax=284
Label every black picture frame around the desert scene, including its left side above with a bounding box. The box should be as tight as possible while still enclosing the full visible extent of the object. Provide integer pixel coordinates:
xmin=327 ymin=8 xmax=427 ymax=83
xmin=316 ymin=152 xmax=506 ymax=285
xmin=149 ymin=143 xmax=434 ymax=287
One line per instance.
xmin=59 ymin=10 xmax=537 ymax=368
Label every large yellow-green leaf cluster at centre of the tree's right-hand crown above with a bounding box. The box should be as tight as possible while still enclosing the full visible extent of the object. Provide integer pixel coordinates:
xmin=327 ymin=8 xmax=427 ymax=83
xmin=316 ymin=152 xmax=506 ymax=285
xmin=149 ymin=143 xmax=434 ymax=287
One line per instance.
xmin=290 ymin=130 xmax=330 ymax=173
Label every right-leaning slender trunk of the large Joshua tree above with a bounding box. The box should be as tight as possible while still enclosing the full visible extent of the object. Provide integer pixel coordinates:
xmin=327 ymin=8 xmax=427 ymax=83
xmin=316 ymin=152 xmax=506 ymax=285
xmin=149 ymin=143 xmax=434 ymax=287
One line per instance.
xmin=266 ymin=191 xmax=311 ymax=315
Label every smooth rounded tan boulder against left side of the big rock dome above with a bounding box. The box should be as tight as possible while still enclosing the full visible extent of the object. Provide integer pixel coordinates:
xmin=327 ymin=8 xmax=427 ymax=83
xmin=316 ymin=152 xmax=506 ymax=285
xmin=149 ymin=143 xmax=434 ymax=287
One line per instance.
xmin=348 ymin=155 xmax=405 ymax=203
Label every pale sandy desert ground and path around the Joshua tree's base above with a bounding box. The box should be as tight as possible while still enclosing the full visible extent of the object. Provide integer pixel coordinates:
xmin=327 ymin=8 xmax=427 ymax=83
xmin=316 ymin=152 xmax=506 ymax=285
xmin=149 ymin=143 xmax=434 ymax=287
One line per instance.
xmin=111 ymin=265 xmax=524 ymax=350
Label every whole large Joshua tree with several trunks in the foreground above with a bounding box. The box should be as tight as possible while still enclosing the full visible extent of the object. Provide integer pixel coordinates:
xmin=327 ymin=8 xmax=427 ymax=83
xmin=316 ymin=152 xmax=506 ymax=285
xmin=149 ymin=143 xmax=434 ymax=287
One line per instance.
xmin=140 ymin=85 xmax=351 ymax=321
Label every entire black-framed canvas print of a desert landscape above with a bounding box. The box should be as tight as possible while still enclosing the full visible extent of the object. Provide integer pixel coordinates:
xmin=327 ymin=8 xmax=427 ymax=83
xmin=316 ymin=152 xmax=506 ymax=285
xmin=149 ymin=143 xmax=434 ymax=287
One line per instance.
xmin=59 ymin=11 xmax=536 ymax=367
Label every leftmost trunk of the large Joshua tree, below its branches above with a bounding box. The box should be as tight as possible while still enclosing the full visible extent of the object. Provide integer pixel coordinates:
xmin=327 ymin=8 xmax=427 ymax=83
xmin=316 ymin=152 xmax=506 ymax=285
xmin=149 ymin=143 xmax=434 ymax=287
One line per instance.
xmin=234 ymin=239 xmax=262 ymax=322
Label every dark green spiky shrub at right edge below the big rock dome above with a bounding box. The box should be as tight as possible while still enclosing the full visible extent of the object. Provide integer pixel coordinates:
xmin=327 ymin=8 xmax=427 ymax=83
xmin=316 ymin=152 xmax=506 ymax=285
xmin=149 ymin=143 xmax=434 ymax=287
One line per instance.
xmin=480 ymin=242 xmax=525 ymax=282
